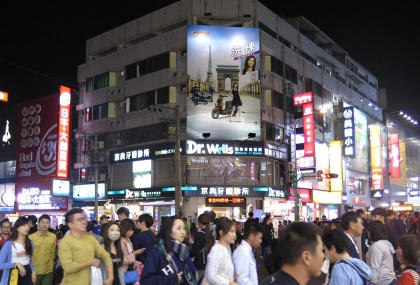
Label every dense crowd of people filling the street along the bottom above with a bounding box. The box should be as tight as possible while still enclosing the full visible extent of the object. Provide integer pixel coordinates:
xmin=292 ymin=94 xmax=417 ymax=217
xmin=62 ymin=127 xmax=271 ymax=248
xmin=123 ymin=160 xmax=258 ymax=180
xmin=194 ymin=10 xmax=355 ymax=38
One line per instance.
xmin=0 ymin=207 xmax=420 ymax=285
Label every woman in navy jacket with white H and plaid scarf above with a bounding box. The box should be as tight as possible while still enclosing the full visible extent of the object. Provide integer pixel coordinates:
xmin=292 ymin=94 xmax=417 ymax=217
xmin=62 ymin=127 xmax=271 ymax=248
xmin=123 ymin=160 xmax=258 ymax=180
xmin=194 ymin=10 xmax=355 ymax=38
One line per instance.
xmin=140 ymin=216 xmax=197 ymax=285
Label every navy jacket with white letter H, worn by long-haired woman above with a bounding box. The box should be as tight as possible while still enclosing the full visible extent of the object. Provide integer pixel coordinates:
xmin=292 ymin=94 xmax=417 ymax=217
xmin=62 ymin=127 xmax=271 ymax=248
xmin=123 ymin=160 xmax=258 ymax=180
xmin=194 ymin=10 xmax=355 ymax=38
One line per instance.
xmin=140 ymin=247 xmax=184 ymax=285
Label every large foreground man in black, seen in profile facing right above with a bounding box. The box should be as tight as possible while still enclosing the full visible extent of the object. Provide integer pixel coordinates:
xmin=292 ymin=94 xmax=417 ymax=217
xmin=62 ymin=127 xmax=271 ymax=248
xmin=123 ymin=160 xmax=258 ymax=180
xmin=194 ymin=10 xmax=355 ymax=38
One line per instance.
xmin=260 ymin=222 xmax=324 ymax=285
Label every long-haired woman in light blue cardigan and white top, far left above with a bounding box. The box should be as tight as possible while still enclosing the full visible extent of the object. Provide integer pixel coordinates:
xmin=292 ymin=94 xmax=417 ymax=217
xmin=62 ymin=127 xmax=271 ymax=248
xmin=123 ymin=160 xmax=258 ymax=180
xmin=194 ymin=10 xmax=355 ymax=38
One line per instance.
xmin=0 ymin=217 xmax=36 ymax=285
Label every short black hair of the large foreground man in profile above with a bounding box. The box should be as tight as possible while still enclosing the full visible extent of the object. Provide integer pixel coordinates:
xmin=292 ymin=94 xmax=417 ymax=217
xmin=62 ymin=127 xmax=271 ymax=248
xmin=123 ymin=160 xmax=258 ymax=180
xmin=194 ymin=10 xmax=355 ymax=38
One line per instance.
xmin=277 ymin=222 xmax=322 ymax=265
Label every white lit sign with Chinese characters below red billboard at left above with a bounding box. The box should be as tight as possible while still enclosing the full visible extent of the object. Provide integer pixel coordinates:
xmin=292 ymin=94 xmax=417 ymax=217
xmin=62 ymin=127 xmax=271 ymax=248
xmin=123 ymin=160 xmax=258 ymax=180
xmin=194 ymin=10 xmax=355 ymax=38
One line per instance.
xmin=17 ymin=186 xmax=68 ymax=211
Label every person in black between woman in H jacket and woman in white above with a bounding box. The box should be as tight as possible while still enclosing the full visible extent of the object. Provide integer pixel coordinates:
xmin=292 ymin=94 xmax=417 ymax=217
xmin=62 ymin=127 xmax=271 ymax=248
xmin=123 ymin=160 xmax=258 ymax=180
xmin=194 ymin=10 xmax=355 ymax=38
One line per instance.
xmin=190 ymin=213 xmax=212 ymax=280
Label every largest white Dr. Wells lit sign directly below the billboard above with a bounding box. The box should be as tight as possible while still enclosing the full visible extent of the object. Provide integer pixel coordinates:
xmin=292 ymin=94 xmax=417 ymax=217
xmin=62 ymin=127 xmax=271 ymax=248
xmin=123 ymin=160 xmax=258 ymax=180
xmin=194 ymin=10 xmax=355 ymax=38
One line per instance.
xmin=186 ymin=140 xmax=263 ymax=156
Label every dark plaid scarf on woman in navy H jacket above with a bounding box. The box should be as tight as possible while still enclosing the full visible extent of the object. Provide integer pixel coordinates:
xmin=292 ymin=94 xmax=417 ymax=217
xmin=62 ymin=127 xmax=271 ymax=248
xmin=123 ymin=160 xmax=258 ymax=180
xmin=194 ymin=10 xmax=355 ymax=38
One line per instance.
xmin=156 ymin=239 xmax=197 ymax=285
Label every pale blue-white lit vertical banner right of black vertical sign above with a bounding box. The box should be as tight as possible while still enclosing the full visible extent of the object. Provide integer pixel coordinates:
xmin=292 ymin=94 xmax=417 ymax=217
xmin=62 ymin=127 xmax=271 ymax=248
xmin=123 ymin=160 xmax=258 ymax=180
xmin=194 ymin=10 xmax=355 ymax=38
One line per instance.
xmin=346 ymin=109 xmax=369 ymax=173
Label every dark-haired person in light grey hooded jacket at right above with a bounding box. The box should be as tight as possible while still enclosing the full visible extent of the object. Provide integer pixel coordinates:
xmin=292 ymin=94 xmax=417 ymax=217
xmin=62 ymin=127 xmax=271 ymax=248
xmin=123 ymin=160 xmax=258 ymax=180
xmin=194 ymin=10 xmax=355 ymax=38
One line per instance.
xmin=366 ymin=221 xmax=397 ymax=285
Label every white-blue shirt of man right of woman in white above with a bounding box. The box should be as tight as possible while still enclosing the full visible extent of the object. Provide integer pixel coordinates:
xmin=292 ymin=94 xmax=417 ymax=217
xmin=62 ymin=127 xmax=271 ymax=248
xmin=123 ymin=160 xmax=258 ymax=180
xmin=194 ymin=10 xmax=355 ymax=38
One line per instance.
xmin=232 ymin=240 xmax=258 ymax=285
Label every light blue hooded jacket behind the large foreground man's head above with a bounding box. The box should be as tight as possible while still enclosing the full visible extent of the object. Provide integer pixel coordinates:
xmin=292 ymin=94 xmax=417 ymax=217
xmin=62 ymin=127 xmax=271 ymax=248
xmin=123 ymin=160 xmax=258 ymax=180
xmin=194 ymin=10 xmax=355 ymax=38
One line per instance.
xmin=328 ymin=258 xmax=372 ymax=285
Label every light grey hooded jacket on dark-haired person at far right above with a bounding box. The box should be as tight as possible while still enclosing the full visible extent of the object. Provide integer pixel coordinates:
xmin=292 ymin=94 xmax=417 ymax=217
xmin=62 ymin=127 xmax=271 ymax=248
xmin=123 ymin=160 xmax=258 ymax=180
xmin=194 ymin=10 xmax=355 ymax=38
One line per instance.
xmin=366 ymin=240 xmax=396 ymax=285
